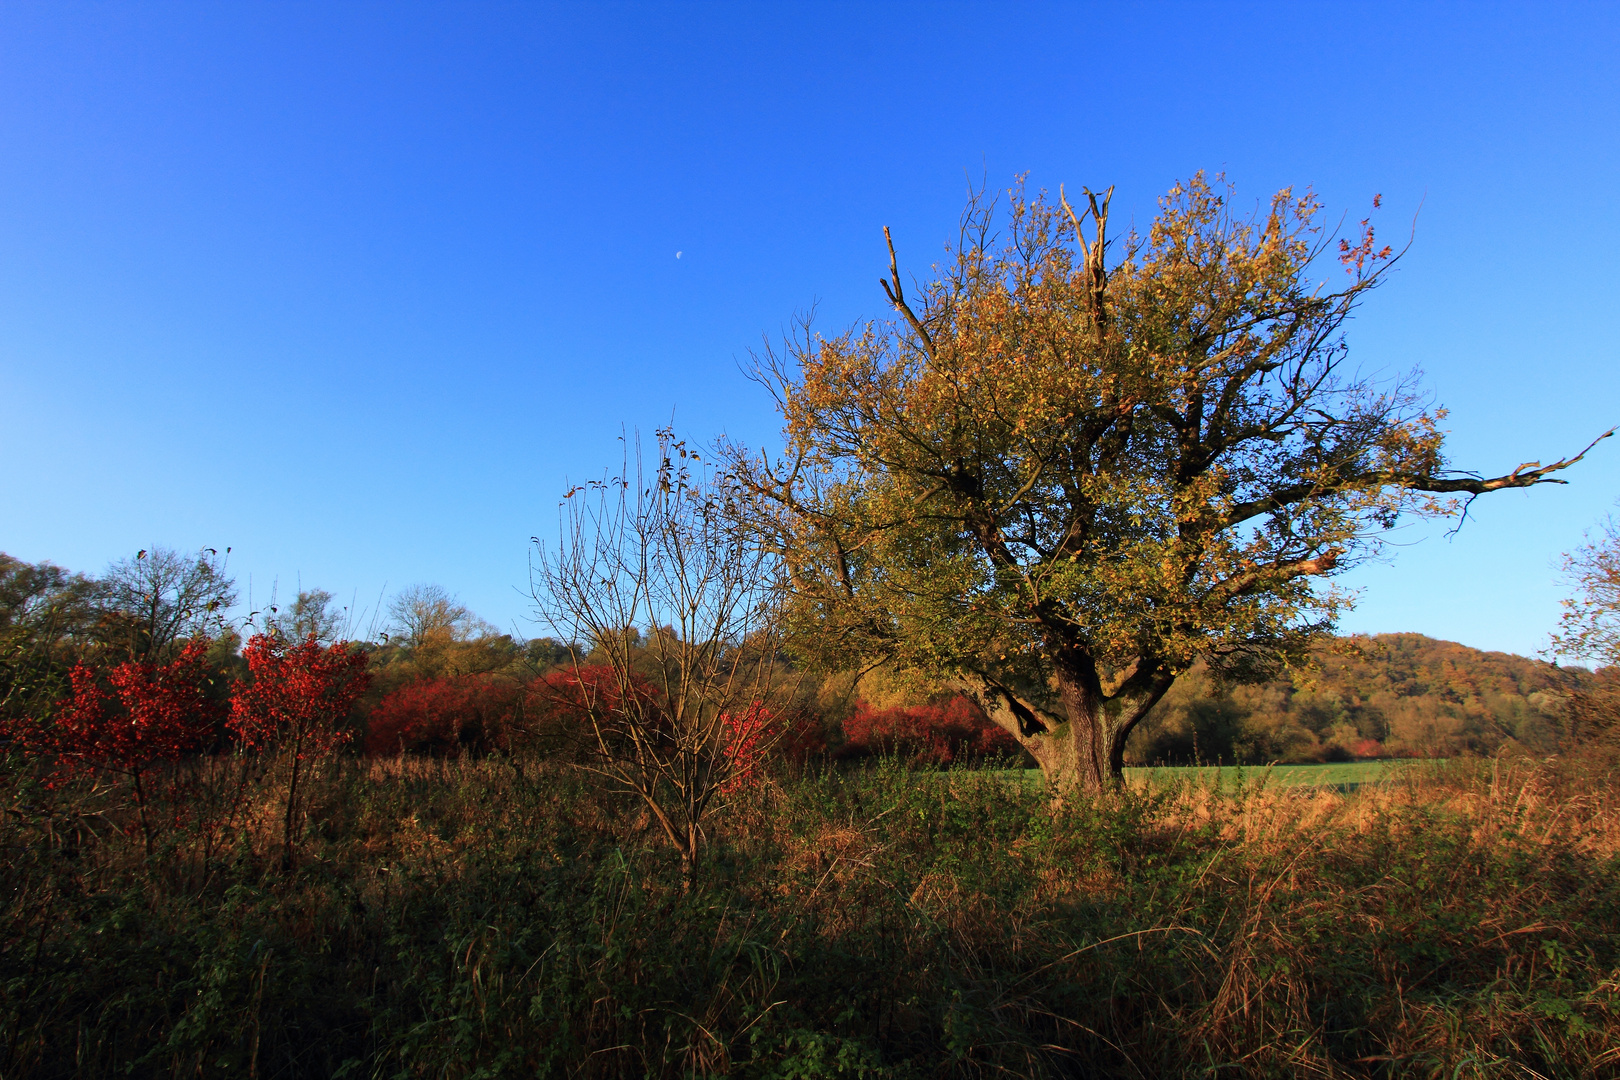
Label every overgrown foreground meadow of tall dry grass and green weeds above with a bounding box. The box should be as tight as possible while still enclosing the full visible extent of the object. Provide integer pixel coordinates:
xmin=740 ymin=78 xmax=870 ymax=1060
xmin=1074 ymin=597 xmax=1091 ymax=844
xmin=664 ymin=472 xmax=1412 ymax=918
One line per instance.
xmin=0 ymin=758 xmax=1620 ymax=1080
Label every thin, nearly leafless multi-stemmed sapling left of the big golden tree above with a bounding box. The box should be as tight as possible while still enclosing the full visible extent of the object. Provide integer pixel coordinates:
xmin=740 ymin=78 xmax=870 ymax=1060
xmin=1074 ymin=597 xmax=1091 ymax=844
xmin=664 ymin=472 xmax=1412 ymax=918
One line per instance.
xmin=533 ymin=431 xmax=776 ymax=879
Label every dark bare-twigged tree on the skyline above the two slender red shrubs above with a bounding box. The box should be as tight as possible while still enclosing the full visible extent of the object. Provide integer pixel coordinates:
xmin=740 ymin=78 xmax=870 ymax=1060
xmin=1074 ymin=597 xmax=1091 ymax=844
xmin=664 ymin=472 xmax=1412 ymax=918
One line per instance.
xmin=96 ymin=547 xmax=237 ymax=661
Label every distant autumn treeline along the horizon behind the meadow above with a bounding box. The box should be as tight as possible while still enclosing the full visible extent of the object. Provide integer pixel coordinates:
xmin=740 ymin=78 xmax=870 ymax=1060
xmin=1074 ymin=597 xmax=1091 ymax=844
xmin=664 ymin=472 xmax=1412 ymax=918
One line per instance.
xmin=0 ymin=549 xmax=1594 ymax=764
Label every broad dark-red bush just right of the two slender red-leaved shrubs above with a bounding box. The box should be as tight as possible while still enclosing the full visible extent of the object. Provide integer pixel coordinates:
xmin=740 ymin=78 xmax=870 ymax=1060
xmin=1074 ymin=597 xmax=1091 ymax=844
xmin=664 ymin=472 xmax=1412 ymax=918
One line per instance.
xmin=366 ymin=677 xmax=527 ymax=758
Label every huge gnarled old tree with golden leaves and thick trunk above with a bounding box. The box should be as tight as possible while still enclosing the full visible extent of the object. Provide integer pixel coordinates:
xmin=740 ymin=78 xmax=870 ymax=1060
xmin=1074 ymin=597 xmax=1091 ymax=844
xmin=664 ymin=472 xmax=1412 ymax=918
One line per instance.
xmin=729 ymin=175 xmax=1607 ymax=793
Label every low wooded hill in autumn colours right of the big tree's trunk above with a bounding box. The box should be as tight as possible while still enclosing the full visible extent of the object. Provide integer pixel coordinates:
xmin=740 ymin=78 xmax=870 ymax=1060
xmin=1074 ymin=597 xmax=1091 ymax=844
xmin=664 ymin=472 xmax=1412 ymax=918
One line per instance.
xmin=1128 ymin=633 xmax=1591 ymax=764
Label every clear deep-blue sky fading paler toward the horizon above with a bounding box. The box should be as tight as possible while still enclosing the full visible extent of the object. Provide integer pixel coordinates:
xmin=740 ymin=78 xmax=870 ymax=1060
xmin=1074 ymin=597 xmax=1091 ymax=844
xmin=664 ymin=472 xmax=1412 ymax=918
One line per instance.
xmin=0 ymin=0 xmax=1620 ymax=653
